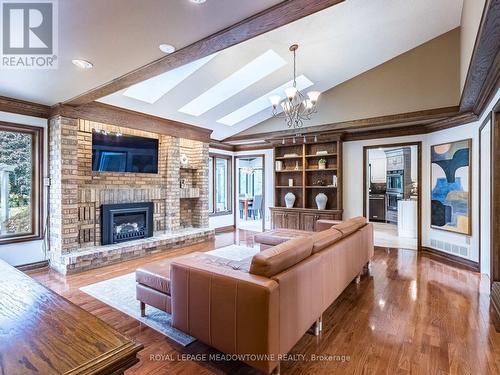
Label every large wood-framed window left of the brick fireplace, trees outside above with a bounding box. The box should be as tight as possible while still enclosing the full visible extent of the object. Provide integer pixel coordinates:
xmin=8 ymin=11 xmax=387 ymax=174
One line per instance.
xmin=0 ymin=122 xmax=43 ymax=244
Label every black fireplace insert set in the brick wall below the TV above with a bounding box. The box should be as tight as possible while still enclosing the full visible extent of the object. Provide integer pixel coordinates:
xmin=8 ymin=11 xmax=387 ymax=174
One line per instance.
xmin=101 ymin=202 xmax=154 ymax=245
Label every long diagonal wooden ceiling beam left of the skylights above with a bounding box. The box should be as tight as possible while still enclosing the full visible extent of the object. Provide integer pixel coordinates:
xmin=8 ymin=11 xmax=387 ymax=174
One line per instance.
xmin=65 ymin=0 xmax=344 ymax=106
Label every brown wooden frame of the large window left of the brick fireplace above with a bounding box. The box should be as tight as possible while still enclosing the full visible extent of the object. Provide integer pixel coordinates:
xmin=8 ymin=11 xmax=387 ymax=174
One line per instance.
xmin=0 ymin=121 xmax=44 ymax=246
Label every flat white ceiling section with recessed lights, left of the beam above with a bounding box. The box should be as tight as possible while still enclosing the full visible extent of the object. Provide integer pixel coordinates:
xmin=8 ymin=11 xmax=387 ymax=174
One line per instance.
xmin=0 ymin=0 xmax=282 ymax=105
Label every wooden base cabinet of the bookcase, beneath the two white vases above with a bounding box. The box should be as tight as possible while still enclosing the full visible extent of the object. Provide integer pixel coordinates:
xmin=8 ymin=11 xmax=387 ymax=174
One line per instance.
xmin=270 ymin=207 xmax=342 ymax=232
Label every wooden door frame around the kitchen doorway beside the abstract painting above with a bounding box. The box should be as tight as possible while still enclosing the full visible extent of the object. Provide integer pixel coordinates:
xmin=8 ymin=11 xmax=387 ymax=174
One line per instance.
xmin=363 ymin=141 xmax=422 ymax=251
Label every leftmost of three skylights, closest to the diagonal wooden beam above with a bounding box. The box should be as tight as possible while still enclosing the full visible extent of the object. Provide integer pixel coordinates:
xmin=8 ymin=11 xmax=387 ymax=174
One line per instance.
xmin=123 ymin=53 xmax=217 ymax=104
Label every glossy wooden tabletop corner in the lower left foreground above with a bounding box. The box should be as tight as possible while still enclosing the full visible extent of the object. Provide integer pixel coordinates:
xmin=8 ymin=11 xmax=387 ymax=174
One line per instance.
xmin=0 ymin=260 xmax=143 ymax=375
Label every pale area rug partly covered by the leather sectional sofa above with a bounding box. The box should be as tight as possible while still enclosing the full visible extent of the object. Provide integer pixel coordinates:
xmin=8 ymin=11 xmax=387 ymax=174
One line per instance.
xmin=80 ymin=245 xmax=259 ymax=346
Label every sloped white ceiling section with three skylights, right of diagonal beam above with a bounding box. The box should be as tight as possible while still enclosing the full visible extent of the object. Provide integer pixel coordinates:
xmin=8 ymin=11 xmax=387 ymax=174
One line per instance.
xmin=100 ymin=0 xmax=462 ymax=139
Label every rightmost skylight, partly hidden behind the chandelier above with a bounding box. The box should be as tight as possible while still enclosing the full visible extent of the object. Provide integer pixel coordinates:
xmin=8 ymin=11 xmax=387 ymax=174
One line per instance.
xmin=217 ymin=75 xmax=313 ymax=126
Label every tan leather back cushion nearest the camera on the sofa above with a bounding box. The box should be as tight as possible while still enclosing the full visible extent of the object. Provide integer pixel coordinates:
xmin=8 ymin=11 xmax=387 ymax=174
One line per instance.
xmin=250 ymin=237 xmax=313 ymax=277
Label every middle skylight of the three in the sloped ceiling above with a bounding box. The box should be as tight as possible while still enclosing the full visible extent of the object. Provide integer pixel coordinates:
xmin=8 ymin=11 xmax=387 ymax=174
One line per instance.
xmin=179 ymin=50 xmax=286 ymax=116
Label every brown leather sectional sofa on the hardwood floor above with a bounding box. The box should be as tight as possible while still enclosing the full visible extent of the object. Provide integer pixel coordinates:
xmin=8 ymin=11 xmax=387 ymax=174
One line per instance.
xmin=136 ymin=217 xmax=373 ymax=373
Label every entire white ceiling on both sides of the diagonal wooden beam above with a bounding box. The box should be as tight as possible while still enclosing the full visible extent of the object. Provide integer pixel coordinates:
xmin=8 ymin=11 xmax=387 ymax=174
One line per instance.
xmin=0 ymin=0 xmax=462 ymax=139
